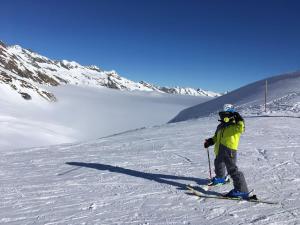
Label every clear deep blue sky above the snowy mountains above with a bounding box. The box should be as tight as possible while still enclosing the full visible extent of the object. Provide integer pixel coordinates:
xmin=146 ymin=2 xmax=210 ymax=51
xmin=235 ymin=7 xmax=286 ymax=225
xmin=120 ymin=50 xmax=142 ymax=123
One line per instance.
xmin=0 ymin=0 xmax=300 ymax=91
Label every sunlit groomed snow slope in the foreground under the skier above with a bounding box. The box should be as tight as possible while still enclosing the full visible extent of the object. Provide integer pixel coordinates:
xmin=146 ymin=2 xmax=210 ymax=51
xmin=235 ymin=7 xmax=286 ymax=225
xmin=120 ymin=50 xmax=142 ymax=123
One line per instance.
xmin=0 ymin=117 xmax=300 ymax=225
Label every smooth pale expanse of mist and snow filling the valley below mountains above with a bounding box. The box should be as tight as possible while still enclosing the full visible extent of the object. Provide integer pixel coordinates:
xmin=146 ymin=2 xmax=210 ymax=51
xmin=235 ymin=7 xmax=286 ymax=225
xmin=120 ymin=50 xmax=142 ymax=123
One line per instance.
xmin=0 ymin=84 xmax=211 ymax=149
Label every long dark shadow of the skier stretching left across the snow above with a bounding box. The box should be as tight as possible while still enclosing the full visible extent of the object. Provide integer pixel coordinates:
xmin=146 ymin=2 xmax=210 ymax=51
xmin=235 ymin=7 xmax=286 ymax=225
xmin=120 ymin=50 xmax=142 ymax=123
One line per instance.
xmin=66 ymin=162 xmax=218 ymax=194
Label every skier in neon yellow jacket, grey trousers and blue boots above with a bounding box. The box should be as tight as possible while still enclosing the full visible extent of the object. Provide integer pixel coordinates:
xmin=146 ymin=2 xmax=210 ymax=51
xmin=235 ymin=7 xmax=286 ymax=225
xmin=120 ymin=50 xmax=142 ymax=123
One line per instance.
xmin=204 ymin=104 xmax=249 ymax=199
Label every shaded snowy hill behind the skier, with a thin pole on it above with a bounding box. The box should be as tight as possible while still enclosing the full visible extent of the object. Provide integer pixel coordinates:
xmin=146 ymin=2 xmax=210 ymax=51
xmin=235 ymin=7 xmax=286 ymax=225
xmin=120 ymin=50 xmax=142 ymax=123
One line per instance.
xmin=170 ymin=72 xmax=300 ymax=122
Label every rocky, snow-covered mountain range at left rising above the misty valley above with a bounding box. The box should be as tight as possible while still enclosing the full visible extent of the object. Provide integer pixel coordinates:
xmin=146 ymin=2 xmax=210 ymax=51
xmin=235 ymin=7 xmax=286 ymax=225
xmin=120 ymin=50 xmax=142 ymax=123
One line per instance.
xmin=0 ymin=42 xmax=220 ymax=101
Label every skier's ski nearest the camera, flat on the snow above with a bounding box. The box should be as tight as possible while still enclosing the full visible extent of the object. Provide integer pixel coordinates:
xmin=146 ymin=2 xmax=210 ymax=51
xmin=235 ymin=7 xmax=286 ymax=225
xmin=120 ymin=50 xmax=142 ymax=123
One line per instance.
xmin=187 ymin=185 xmax=278 ymax=205
